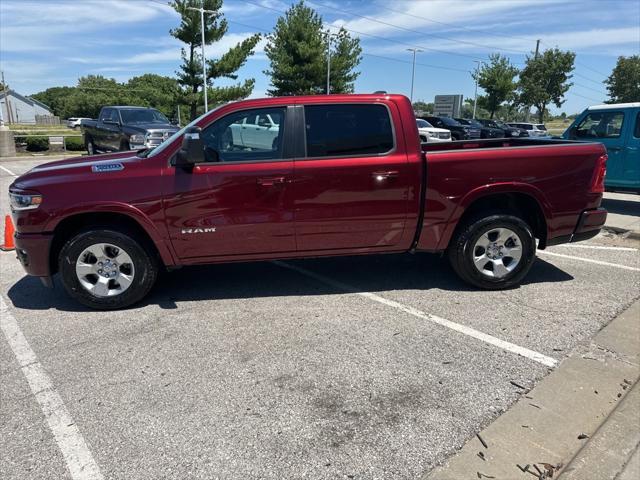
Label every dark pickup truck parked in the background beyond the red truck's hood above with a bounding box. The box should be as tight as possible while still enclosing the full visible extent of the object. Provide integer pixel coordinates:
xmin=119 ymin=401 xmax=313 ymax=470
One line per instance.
xmin=82 ymin=106 xmax=179 ymax=154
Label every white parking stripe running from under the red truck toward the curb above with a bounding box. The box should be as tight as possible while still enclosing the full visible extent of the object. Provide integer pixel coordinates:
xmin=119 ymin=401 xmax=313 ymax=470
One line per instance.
xmin=273 ymin=261 xmax=558 ymax=367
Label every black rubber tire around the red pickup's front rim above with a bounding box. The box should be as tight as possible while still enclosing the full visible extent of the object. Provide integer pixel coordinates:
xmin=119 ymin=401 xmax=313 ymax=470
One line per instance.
xmin=58 ymin=227 xmax=158 ymax=310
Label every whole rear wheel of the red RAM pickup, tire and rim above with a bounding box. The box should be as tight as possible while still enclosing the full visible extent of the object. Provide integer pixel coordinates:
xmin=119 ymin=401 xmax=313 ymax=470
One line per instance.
xmin=447 ymin=213 xmax=536 ymax=290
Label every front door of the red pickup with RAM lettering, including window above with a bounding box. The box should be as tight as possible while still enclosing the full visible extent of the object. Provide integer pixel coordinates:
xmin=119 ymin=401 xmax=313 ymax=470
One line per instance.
xmin=164 ymin=106 xmax=296 ymax=259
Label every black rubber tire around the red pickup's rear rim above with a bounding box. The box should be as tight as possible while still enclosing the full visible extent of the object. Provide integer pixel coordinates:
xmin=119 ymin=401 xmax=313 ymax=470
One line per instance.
xmin=447 ymin=212 xmax=536 ymax=290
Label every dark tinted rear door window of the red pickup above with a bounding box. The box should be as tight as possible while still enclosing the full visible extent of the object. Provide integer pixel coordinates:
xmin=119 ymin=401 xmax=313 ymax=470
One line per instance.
xmin=304 ymin=104 xmax=394 ymax=157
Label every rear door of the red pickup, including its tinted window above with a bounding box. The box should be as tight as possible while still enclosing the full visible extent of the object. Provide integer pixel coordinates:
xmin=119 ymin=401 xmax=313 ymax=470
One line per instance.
xmin=294 ymin=103 xmax=411 ymax=251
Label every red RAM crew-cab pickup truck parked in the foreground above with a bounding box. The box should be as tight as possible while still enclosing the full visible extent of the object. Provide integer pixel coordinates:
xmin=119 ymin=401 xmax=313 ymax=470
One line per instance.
xmin=10 ymin=94 xmax=607 ymax=309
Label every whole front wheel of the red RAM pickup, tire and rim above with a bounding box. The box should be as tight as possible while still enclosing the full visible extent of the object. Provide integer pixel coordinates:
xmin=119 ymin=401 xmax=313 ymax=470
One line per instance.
xmin=58 ymin=228 xmax=158 ymax=310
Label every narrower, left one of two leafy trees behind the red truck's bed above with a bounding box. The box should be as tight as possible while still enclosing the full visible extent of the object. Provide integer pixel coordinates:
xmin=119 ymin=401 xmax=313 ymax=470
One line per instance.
xmin=471 ymin=53 xmax=518 ymax=118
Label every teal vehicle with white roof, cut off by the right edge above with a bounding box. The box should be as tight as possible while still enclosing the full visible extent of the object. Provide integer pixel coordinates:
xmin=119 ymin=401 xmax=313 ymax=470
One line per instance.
xmin=562 ymin=102 xmax=640 ymax=193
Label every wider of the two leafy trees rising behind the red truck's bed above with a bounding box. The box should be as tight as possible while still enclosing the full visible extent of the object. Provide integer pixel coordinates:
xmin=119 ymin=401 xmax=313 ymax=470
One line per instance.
xmin=519 ymin=48 xmax=576 ymax=123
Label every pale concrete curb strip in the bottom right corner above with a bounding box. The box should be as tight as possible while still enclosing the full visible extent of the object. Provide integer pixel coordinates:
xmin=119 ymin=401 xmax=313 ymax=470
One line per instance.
xmin=422 ymin=300 xmax=640 ymax=480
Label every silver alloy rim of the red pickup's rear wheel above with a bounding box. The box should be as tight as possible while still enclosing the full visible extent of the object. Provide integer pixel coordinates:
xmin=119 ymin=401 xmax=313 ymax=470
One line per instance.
xmin=473 ymin=228 xmax=522 ymax=278
